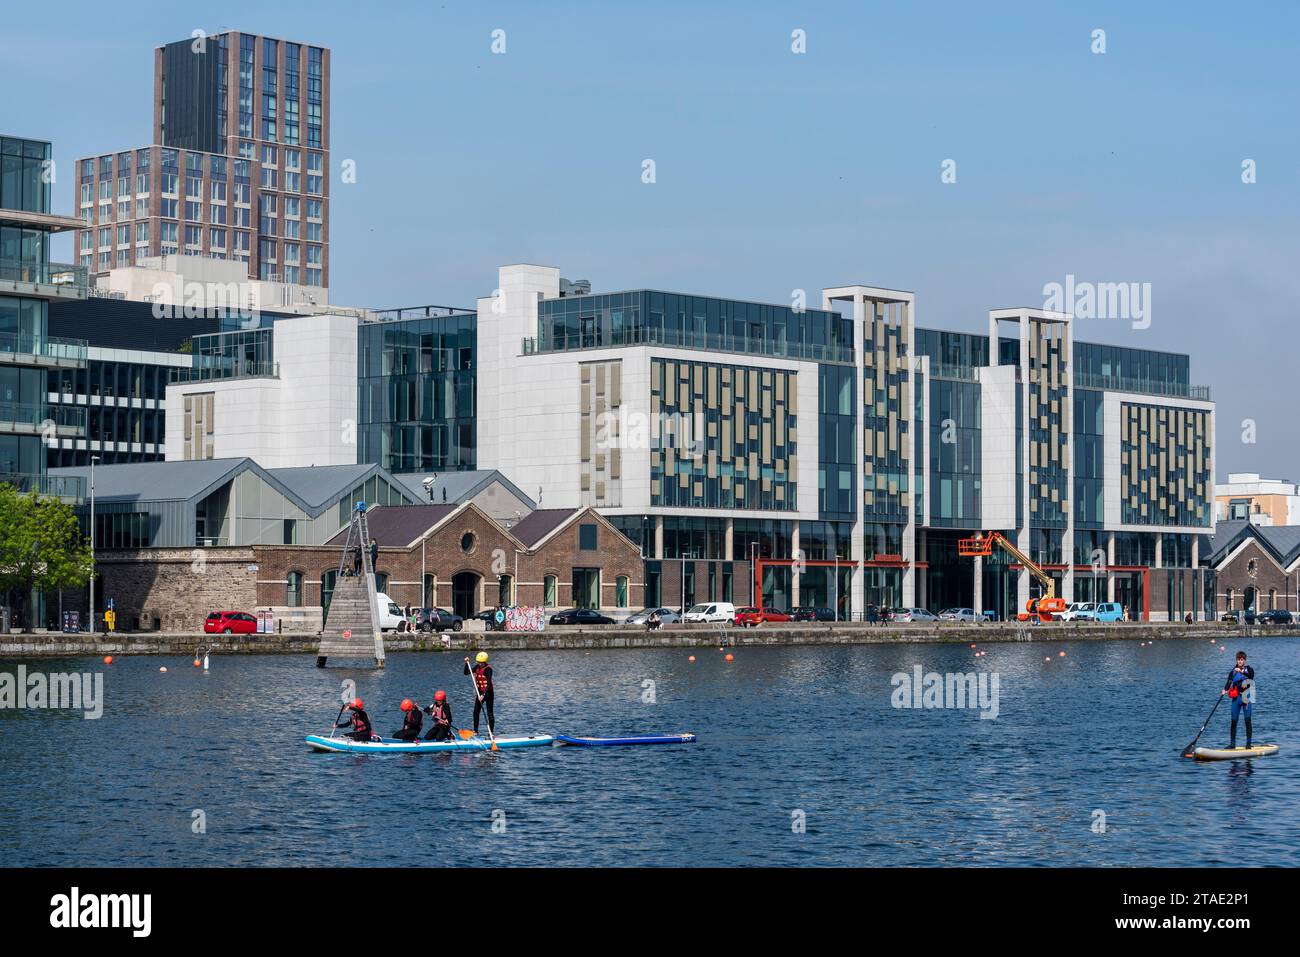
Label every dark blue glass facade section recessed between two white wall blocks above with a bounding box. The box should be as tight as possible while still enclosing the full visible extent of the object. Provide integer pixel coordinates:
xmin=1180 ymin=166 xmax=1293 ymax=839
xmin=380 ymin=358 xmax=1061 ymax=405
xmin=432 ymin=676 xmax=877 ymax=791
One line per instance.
xmin=358 ymin=312 xmax=478 ymax=472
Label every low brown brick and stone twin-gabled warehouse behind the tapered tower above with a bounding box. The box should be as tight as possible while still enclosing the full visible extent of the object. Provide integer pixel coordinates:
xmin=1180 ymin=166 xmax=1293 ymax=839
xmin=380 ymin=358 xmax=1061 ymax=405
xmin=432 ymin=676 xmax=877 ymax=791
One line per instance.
xmin=73 ymin=502 xmax=645 ymax=632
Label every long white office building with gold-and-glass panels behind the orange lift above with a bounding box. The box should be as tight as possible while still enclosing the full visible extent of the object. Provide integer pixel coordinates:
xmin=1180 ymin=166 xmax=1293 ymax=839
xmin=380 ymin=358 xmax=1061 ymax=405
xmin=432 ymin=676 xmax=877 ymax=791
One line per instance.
xmin=467 ymin=265 xmax=1213 ymax=618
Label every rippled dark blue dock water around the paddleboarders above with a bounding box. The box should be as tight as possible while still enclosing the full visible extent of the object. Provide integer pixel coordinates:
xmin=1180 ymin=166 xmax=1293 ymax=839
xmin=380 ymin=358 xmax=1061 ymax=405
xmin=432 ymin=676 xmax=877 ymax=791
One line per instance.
xmin=0 ymin=637 xmax=1300 ymax=866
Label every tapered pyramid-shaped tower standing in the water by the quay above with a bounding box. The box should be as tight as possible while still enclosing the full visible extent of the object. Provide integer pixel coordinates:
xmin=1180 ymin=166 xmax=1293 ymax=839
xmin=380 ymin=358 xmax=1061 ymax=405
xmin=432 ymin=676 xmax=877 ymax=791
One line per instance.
xmin=316 ymin=502 xmax=384 ymax=668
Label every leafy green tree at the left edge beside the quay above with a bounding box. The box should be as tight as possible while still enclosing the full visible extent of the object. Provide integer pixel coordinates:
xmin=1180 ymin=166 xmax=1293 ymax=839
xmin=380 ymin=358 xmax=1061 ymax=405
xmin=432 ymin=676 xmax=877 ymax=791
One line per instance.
xmin=0 ymin=484 xmax=92 ymax=632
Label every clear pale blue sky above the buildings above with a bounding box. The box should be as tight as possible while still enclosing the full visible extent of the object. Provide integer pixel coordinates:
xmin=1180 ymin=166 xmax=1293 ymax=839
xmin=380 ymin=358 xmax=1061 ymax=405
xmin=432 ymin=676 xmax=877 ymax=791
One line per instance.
xmin=0 ymin=0 xmax=1300 ymax=481
